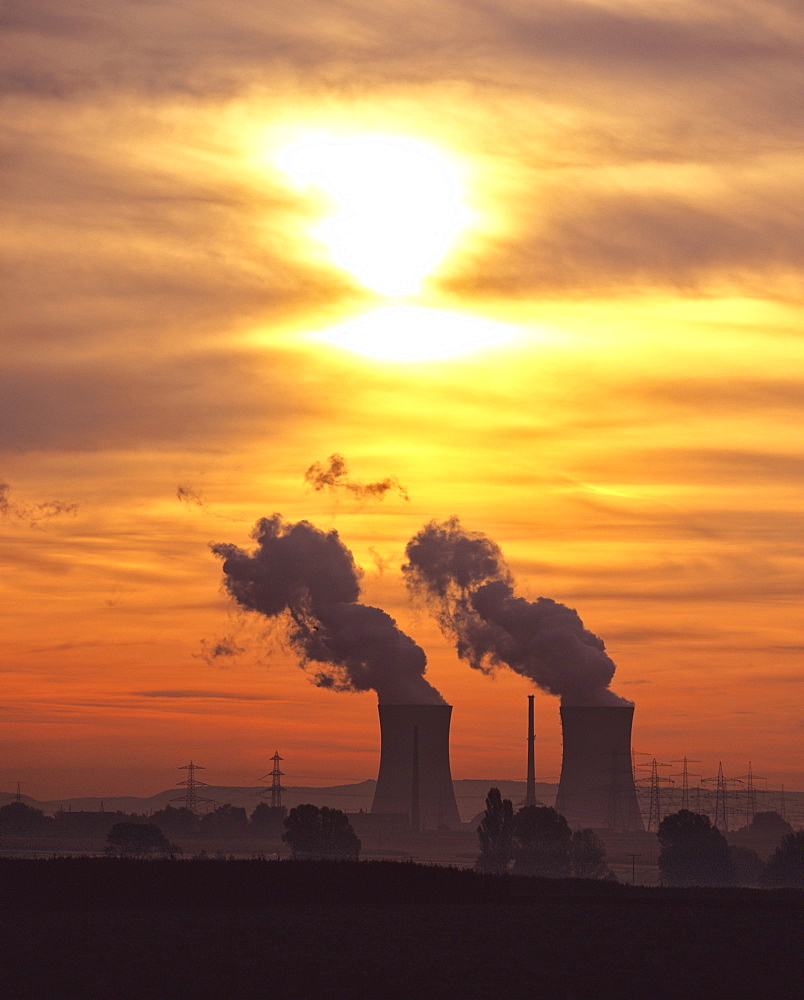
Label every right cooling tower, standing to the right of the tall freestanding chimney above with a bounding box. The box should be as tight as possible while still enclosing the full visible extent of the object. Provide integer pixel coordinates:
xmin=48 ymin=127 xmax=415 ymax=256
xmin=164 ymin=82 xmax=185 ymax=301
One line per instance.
xmin=556 ymin=705 xmax=645 ymax=830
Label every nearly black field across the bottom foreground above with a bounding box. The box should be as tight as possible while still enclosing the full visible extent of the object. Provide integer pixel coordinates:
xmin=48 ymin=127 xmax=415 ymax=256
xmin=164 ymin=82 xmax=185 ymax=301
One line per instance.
xmin=0 ymin=859 xmax=804 ymax=1000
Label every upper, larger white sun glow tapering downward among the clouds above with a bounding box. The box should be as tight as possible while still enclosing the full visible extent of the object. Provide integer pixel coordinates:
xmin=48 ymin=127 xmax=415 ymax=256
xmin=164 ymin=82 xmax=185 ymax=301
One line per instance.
xmin=276 ymin=133 xmax=470 ymax=297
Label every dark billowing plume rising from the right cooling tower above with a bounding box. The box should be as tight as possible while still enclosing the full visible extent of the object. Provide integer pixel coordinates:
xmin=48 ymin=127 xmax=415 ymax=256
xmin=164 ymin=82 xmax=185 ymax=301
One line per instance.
xmin=402 ymin=517 xmax=630 ymax=705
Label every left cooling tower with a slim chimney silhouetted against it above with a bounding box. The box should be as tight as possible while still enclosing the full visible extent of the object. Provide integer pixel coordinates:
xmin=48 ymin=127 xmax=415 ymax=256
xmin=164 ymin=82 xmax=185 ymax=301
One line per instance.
xmin=371 ymin=705 xmax=461 ymax=830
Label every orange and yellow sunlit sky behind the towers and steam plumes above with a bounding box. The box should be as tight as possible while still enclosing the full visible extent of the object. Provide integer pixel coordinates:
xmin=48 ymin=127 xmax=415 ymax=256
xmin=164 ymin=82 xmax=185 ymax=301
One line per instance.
xmin=0 ymin=0 xmax=804 ymax=799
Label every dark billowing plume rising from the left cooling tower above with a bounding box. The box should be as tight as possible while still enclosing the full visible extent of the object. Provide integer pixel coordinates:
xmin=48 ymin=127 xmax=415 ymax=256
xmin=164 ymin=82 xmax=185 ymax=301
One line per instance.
xmin=212 ymin=514 xmax=444 ymax=705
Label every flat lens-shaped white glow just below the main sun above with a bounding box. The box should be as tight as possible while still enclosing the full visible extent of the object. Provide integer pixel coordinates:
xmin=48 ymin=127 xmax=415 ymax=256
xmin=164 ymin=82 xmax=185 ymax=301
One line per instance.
xmin=313 ymin=305 xmax=519 ymax=361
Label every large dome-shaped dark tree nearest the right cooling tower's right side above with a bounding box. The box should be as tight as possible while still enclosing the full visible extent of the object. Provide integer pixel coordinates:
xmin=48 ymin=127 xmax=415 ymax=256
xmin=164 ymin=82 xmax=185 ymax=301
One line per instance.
xmin=658 ymin=809 xmax=734 ymax=885
